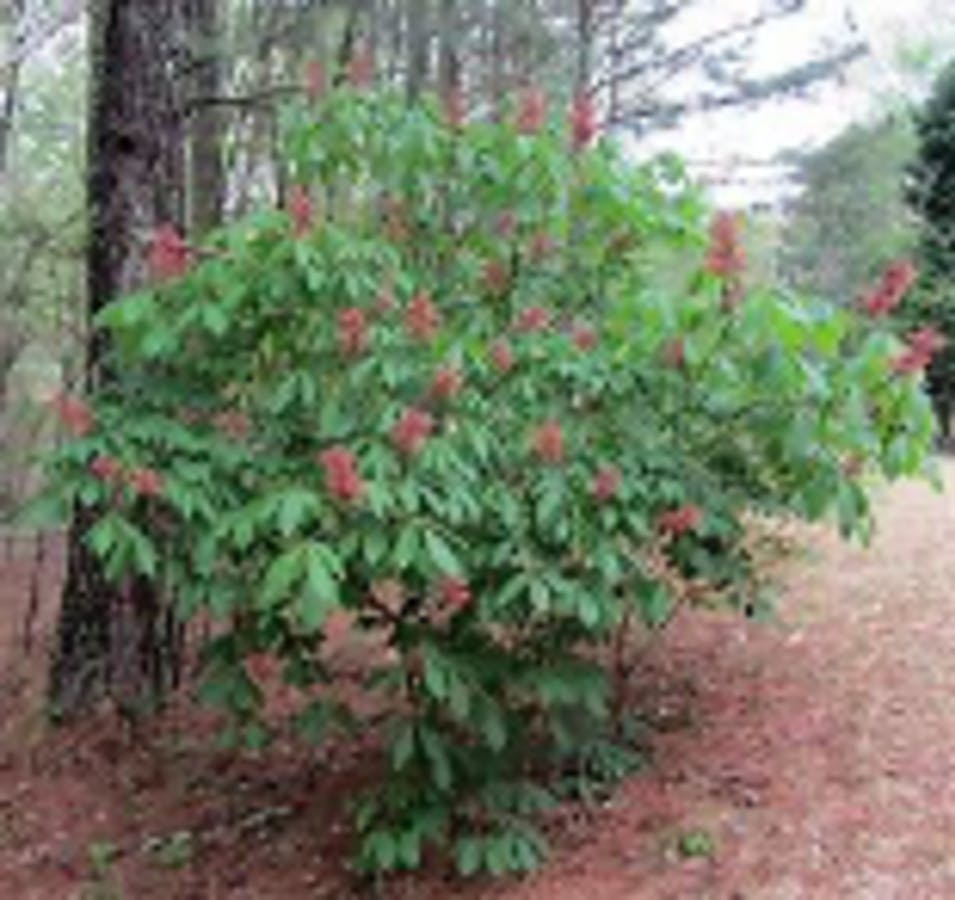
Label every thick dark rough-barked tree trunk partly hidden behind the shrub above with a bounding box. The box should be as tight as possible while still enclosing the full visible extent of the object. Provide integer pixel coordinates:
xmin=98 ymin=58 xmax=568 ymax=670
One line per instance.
xmin=50 ymin=0 xmax=185 ymax=718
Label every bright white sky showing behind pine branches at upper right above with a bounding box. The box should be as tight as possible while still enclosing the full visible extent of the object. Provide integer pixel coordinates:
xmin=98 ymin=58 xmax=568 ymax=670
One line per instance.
xmin=640 ymin=0 xmax=955 ymax=205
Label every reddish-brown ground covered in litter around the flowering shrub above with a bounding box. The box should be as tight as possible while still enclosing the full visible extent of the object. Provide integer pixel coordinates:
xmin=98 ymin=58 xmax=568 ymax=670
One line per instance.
xmin=0 ymin=464 xmax=955 ymax=900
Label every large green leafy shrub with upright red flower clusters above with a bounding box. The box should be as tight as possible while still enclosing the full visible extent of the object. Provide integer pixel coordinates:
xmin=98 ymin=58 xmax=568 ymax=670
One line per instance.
xmin=39 ymin=87 xmax=932 ymax=873
